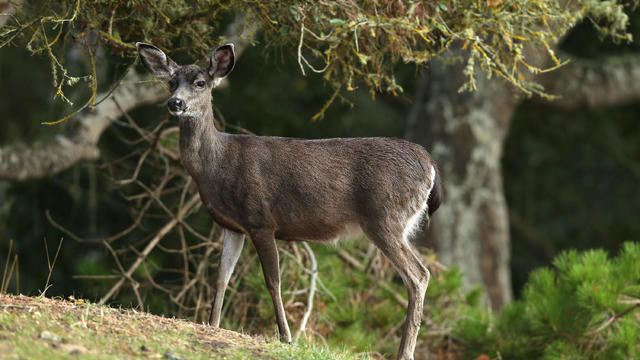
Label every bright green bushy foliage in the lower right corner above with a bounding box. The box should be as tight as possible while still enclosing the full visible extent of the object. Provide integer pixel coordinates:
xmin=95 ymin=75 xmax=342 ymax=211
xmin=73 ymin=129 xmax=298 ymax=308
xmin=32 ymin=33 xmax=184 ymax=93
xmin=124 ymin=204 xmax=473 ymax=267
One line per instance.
xmin=455 ymin=242 xmax=640 ymax=359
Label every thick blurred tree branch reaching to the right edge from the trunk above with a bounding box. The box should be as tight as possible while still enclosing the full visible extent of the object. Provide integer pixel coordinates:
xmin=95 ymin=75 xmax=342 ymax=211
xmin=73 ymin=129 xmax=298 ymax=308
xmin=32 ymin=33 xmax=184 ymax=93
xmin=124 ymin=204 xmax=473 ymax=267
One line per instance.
xmin=535 ymin=54 xmax=640 ymax=109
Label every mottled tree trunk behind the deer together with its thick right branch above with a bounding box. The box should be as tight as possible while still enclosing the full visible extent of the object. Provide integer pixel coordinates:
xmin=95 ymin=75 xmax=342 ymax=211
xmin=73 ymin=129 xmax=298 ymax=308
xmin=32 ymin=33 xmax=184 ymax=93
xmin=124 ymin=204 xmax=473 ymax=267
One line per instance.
xmin=406 ymin=50 xmax=640 ymax=309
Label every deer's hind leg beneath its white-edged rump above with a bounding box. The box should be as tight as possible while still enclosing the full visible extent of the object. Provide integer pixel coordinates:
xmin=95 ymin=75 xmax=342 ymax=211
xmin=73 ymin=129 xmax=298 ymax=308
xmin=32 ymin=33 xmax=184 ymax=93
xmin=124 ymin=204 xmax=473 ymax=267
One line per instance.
xmin=365 ymin=226 xmax=430 ymax=360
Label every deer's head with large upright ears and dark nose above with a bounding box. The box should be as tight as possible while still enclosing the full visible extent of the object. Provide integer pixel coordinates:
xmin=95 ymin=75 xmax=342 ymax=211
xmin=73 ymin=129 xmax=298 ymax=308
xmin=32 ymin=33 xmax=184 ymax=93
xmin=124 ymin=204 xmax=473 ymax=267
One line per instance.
xmin=136 ymin=42 xmax=235 ymax=117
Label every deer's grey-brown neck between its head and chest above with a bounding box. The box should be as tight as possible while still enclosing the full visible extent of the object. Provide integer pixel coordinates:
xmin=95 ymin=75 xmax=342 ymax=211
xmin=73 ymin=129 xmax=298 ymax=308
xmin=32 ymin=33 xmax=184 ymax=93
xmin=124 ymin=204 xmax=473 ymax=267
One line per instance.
xmin=180 ymin=106 xmax=223 ymax=180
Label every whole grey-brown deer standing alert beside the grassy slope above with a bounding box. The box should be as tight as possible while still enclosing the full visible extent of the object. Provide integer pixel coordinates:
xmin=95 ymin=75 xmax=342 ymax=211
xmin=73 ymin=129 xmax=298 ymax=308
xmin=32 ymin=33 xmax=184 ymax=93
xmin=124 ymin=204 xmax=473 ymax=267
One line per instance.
xmin=136 ymin=42 xmax=442 ymax=360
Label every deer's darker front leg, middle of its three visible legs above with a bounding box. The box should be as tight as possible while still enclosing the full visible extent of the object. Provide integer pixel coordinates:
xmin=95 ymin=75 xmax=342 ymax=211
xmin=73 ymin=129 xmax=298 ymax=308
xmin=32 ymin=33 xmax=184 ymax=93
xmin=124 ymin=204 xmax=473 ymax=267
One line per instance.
xmin=251 ymin=232 xmax=291 ymax=344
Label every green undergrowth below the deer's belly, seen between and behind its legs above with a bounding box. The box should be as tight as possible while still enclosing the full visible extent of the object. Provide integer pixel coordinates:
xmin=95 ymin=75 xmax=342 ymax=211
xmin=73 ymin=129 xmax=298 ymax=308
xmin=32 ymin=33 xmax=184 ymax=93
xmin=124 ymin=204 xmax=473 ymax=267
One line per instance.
xmin=222 ymin=240 xmax=481 ymax=356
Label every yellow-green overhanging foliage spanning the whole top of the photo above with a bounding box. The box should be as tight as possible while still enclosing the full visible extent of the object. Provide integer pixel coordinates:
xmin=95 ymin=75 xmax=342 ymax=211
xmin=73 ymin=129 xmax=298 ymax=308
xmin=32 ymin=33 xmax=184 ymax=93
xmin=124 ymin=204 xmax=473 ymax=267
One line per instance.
xmin=0 ymin=0 xmax=637 ymax=121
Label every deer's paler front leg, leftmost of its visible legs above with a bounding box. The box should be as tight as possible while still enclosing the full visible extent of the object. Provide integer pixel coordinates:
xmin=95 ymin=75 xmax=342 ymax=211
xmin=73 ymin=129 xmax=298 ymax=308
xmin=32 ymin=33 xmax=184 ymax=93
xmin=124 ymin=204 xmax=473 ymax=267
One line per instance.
xmin=209 ymin=230 xmax=244 ymax=328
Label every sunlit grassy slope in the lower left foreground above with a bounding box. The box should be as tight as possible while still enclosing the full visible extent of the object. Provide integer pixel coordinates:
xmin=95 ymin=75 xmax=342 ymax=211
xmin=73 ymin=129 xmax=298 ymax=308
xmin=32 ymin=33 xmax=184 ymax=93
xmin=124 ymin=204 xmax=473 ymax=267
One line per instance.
xmin=0 ymin=294 xmax=359 ymax=360
